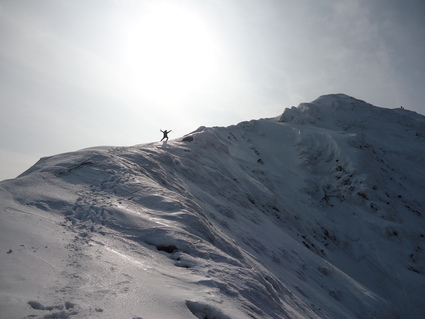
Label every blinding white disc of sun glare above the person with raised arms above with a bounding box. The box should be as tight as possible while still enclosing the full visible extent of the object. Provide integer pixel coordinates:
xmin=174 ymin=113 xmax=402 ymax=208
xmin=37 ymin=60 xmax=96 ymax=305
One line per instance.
xmin=126 ymin=4 xmax=218 ymax=102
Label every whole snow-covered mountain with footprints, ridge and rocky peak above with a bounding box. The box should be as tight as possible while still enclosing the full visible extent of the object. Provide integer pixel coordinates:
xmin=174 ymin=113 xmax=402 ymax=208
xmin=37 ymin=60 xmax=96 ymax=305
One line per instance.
xmin=0 ymin=94 xmax=425 ymax=319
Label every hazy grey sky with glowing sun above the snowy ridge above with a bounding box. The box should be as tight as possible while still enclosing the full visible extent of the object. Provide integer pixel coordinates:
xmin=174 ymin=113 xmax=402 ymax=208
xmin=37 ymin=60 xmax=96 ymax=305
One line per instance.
xmin=0 ymin=0 xmax=425 ymax=180
